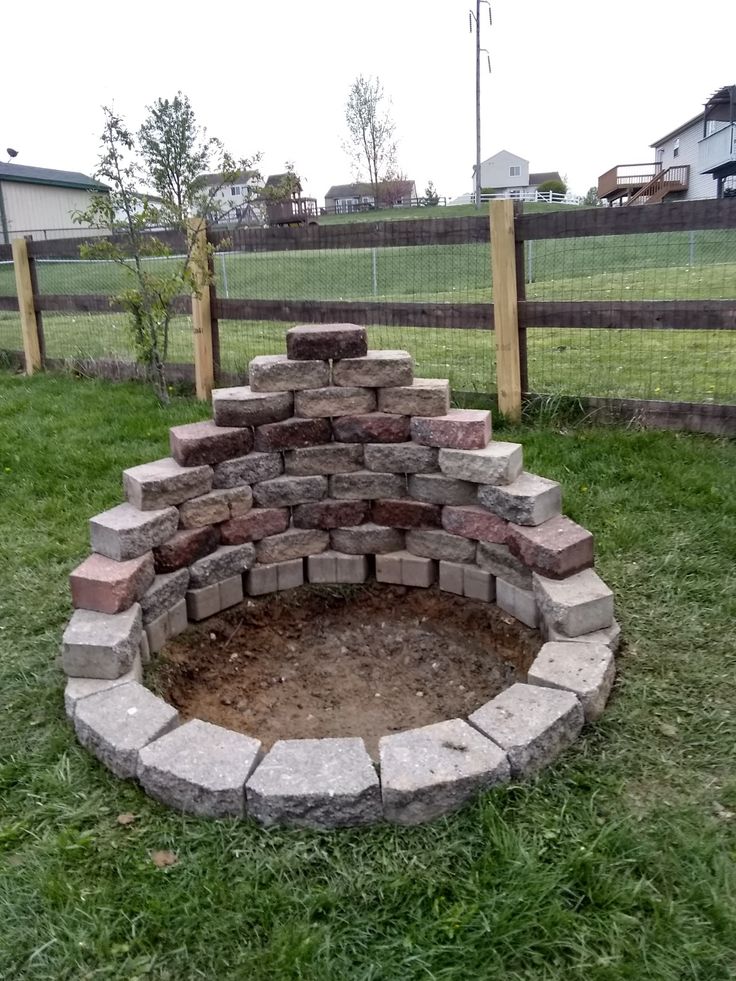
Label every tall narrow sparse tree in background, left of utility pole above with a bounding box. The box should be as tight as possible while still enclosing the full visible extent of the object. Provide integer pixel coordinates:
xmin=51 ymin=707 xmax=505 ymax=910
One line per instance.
xmin=345 ymin=75 xmax=396 ymax=203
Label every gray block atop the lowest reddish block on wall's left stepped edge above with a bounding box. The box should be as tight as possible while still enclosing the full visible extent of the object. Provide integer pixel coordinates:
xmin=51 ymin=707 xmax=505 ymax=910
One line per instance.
xmin=89 ymin=503 xmax=179 ymax=562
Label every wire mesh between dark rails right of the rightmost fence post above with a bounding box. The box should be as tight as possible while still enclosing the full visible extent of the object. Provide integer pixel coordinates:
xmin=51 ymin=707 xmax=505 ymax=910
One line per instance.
xmin=524 ymin=229 xmax=736 ymax=404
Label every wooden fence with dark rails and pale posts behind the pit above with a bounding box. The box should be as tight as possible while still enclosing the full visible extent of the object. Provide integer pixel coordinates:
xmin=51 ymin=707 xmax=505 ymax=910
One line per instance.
xmin=0 ymin=199 xmax=736 ymax=433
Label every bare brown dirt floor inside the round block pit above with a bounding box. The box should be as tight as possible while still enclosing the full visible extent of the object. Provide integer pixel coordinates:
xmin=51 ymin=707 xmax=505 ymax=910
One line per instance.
xmin=151 ymin=583 xmax=542 ymax=758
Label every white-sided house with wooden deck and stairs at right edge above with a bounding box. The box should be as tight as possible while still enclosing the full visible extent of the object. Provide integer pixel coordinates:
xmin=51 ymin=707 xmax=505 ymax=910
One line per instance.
xmin=598 ymin=85 xmax=736 ymax=205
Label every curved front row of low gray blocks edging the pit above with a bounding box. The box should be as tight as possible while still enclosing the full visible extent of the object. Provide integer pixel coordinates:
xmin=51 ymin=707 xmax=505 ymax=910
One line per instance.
xmin=68 ymin=643 xmax=613 ymax=828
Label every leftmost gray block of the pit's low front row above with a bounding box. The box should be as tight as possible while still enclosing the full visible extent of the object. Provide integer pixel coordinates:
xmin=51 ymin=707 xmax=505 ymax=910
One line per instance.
xmin=74 ymin=681 xmax=178 ymax=778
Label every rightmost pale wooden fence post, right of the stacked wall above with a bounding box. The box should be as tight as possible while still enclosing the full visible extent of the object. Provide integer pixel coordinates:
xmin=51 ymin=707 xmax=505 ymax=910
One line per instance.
xmin=491 ymin=200 xmax=521 ymax=422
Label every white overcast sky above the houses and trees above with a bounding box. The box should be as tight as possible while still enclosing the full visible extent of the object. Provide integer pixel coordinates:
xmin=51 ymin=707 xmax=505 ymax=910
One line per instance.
xmin=0 ymin=0 xmax=736 ymax=203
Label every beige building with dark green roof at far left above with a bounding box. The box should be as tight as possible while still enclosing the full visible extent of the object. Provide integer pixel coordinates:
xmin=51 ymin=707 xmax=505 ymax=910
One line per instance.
xmin=0 ymin=163 xmax=108 ymax=245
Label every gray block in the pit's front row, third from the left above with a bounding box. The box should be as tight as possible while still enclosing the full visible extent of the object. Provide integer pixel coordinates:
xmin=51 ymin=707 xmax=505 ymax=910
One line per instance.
xmin=245 ymin=738 xmax=382 ymax=828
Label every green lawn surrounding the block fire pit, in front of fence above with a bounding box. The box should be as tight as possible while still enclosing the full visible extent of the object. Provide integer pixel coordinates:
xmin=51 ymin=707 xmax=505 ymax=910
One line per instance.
xmin=0 ymin=372 xmax=736 ymax=981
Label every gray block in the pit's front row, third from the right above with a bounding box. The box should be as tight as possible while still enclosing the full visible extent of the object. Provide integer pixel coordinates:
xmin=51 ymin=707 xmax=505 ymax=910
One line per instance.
xmin=379 ymin=719 xmax=510 ymax=825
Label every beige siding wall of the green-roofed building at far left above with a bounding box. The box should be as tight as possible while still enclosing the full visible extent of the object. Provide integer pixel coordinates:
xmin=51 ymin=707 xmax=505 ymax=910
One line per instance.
xmin=0 ymin=181 xmax=103 ymax=239
